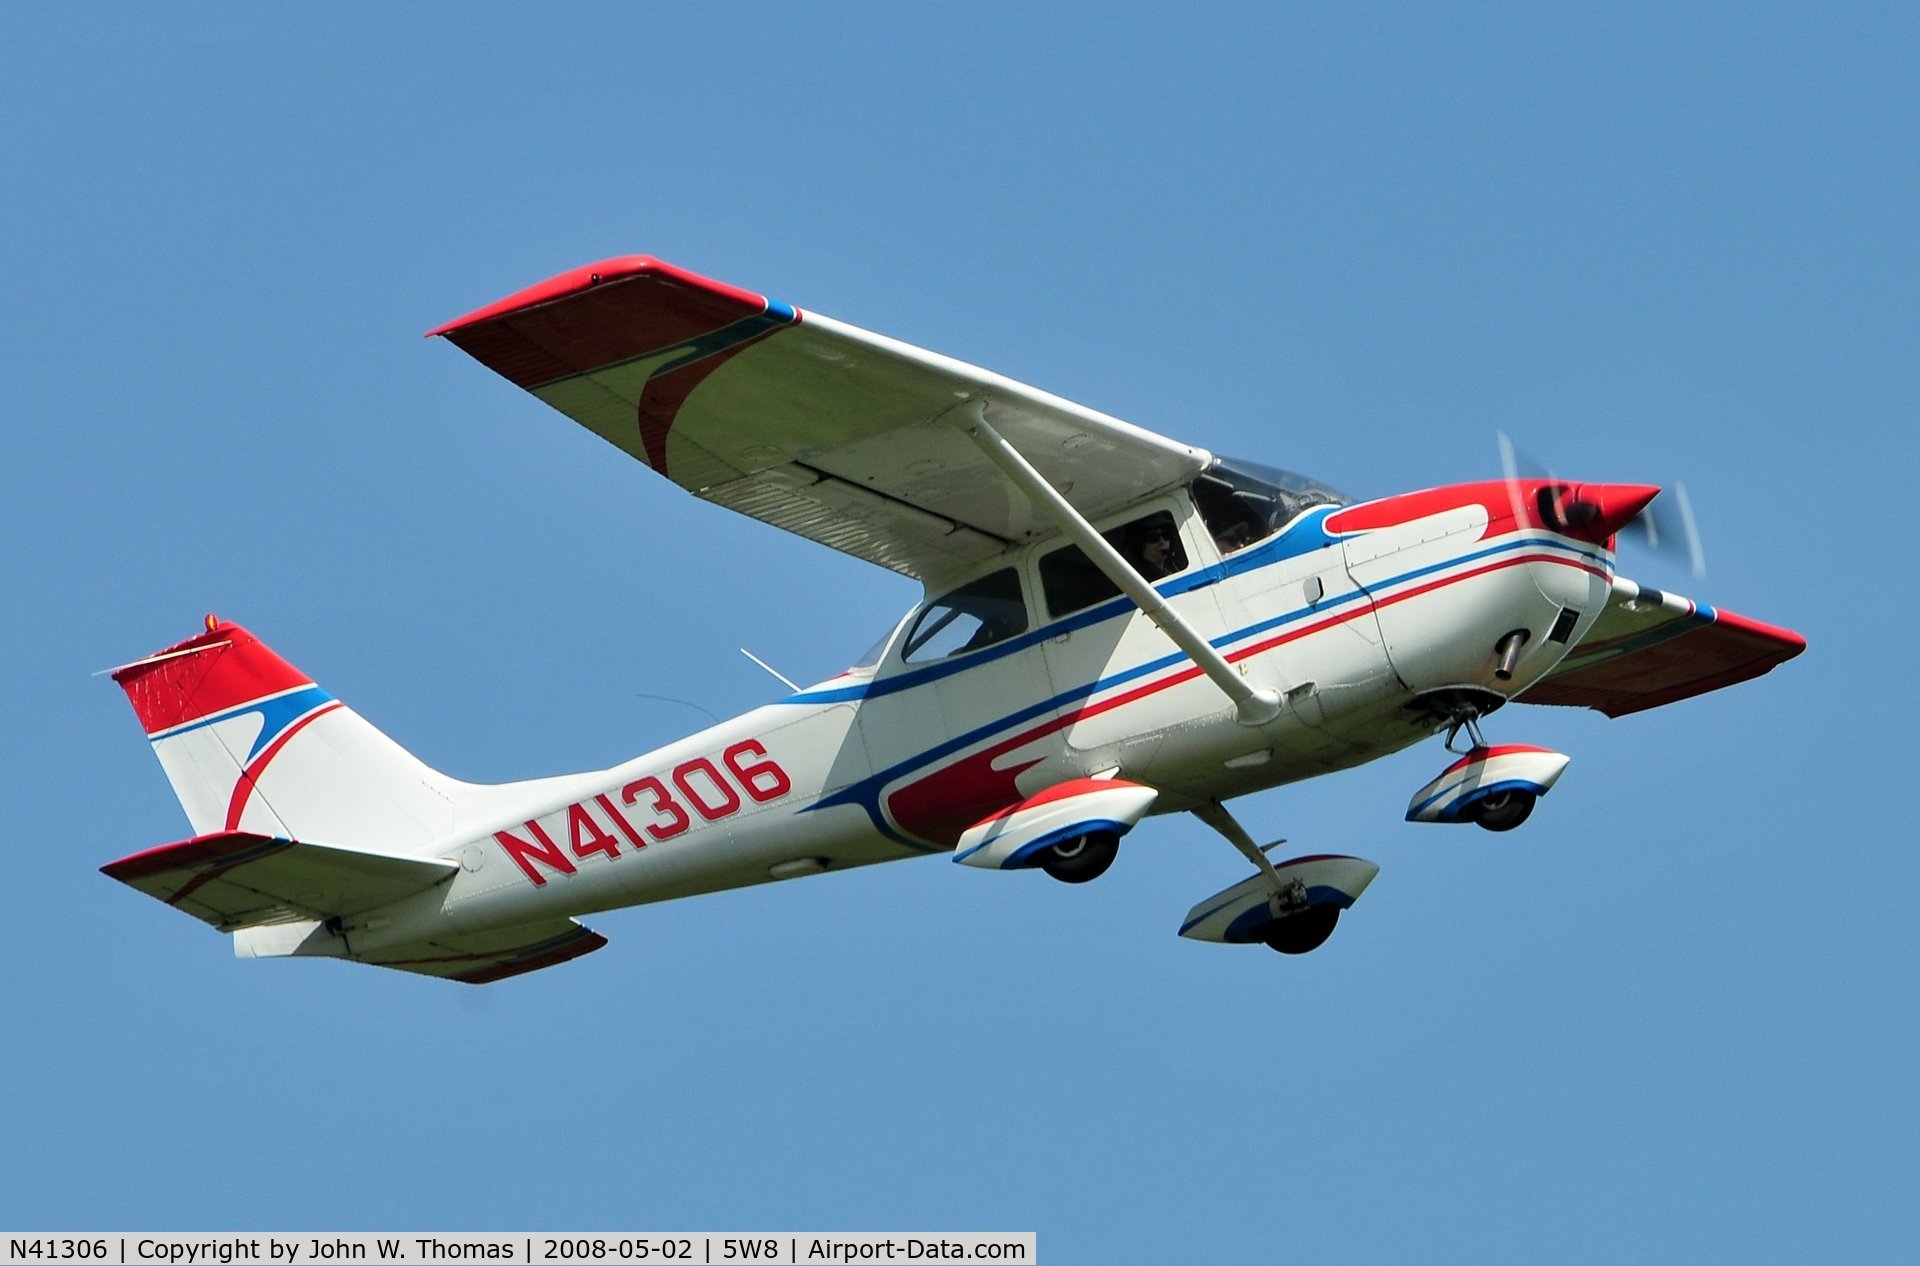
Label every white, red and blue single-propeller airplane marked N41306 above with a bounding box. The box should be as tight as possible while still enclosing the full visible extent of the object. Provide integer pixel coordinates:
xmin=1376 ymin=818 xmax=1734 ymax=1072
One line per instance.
xmin=102 ymin=256 xmax=1807 ymax=984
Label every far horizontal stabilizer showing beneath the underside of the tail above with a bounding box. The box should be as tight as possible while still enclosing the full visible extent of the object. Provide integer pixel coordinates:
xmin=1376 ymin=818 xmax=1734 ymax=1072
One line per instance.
xmin=234 ymin=918 xmax=607 ymax=986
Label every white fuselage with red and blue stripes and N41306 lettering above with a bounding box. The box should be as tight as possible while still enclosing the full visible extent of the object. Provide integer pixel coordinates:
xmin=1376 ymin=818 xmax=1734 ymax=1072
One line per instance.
xmin=346 ymin=480 xmax=1613 ymax=951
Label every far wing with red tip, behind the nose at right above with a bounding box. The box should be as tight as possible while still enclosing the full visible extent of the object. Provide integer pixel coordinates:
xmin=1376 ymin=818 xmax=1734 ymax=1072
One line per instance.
xmin=1521 ymin=576 xmax=1807 ymax=717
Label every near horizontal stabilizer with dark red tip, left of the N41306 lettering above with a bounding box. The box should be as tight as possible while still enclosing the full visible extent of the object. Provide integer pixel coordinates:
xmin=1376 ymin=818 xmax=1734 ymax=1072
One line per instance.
xmin=100 ymin=830 xmax=457 ymax=932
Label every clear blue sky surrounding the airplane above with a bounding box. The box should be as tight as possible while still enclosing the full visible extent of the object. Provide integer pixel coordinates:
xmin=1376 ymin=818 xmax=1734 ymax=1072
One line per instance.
xmin=0 ymin=4 xmax=1920 ymax=1266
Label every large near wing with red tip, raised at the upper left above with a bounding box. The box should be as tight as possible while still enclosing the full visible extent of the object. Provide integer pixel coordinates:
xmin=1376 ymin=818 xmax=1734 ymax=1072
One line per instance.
xmin=428 ymin=256 xmax=1210 ymax=580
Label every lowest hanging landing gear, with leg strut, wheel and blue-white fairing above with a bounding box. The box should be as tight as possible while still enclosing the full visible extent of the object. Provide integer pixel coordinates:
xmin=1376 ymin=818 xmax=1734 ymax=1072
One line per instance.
xmin=1181 ymin=801 xmax=1380 ymax=955
